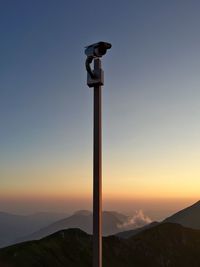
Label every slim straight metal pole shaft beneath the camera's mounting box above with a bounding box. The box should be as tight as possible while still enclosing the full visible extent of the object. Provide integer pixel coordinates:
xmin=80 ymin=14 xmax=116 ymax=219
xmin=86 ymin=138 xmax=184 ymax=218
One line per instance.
xmin=93 ymin=59 xmax=102 ymax=267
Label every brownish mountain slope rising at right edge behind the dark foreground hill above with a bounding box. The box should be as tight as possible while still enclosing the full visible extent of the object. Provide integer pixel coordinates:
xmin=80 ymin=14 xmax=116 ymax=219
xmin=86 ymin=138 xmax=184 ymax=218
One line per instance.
xmin=164 ymin=201 xmax=200 ymax=229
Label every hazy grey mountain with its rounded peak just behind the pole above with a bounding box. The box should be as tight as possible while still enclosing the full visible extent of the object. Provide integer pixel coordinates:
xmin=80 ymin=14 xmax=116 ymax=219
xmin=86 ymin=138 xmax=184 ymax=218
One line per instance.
xmin=16 ymin=210 xmax=128 ymax=242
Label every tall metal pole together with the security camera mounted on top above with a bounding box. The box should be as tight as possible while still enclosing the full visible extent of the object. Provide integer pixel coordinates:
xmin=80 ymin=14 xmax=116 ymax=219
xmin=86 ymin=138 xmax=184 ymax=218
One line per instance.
xmin=85 ymin=42 xmax=112 ymax=267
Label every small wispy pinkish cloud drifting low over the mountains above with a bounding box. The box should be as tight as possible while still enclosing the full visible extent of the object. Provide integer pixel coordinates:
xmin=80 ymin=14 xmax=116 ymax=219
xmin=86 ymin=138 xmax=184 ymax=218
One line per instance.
xmin=118 ymin=210 xmax=152 ymax=230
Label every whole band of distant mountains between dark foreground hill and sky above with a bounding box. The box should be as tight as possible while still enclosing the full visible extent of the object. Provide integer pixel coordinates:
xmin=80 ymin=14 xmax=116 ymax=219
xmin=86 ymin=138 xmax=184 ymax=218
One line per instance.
xmin=0 ymin=201 xmax=200 ymax=250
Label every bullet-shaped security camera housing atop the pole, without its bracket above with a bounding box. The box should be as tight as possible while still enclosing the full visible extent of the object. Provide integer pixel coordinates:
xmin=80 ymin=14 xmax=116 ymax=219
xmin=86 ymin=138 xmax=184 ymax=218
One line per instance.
xmin=85 ymin=42 xmax=112 ymax=58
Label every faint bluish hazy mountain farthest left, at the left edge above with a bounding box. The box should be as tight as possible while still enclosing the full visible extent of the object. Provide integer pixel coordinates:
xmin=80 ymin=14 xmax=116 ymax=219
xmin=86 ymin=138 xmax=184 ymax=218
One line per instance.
xmin=0 ymin=212 xmax=66 ymax=247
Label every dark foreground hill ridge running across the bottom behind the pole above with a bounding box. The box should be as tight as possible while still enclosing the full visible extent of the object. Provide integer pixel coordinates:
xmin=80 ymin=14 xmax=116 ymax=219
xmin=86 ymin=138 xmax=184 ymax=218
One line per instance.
xmin=0 ymin=223 xmax=200 ymax=267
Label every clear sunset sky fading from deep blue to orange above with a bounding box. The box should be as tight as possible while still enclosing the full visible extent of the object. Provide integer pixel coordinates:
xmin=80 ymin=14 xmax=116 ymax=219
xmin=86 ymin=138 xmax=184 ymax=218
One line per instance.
xmin=0 ymin=0 xmax=200 ymax=218
